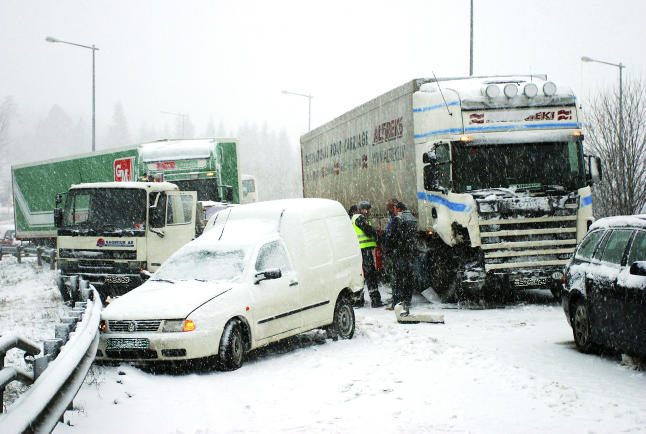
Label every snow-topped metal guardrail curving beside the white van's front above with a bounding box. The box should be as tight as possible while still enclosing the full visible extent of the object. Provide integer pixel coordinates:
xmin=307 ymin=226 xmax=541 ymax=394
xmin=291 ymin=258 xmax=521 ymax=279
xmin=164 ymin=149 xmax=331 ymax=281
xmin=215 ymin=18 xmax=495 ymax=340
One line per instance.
xmin=0 ymin=287 xmax=103 ymax=433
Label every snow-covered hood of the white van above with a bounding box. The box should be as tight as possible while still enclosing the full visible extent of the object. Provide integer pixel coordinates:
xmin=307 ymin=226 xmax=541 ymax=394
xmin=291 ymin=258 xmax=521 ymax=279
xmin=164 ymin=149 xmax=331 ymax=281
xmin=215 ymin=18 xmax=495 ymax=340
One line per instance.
xmin=101 ymin=280 xmax=234 ymax=320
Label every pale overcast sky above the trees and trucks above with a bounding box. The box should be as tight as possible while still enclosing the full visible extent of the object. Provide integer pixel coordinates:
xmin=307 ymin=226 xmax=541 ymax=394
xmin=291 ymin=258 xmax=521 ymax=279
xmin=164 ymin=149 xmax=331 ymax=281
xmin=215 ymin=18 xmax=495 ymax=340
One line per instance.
xmin=0 ymin=0 xmax=646 ymax=152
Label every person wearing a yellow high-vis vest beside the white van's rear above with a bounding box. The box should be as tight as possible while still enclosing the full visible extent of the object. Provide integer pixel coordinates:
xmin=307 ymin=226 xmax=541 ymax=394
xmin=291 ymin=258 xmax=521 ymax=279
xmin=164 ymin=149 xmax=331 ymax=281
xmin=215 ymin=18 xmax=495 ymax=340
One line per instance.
xmin=352 ymin=201 xmax=384 ymax=307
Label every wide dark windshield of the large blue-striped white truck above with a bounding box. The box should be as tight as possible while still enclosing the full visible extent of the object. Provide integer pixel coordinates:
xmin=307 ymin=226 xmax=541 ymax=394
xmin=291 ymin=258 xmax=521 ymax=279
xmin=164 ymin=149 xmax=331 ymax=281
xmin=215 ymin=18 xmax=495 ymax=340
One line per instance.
xmin=452 ymin=141 xmax=585 ymax=192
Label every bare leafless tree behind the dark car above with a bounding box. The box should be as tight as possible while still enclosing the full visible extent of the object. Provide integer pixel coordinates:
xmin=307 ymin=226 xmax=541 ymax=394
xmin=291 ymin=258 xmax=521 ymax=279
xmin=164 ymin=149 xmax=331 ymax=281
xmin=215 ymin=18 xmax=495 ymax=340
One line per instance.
xmin=584 ymin=79 xmax=646 ymax=217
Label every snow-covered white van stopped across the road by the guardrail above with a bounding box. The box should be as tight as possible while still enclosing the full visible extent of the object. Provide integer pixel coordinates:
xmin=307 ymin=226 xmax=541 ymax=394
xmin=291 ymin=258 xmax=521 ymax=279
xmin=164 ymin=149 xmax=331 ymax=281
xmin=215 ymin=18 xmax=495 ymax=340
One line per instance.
xmin=97 ymin=199 xmax=363 ymax=370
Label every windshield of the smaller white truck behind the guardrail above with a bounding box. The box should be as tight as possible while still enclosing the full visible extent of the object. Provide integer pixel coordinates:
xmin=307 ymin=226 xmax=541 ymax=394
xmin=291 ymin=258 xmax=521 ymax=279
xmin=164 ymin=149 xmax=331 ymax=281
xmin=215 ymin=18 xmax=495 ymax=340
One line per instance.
xmin=63 ymin=188 xmax=146 ymax=231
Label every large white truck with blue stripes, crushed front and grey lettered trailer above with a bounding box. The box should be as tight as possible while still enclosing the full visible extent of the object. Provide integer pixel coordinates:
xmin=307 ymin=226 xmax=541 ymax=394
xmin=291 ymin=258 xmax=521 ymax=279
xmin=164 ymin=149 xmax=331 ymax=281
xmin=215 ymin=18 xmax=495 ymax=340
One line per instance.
xmin=301 ymin=75 xmax=600 ymax=300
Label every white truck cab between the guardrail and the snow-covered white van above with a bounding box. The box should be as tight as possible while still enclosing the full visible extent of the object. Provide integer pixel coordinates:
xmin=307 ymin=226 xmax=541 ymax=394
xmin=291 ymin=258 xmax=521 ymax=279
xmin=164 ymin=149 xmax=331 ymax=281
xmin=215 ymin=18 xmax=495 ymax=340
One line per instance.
xmin=54 ymin=182 xmax=196 ymax=299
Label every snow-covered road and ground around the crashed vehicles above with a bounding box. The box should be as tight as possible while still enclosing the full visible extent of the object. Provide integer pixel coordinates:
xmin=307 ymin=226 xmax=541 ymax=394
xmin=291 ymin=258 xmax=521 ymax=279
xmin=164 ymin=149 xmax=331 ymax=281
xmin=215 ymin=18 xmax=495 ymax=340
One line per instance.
xmin=0 ymin=259 xmax=646 ymax=433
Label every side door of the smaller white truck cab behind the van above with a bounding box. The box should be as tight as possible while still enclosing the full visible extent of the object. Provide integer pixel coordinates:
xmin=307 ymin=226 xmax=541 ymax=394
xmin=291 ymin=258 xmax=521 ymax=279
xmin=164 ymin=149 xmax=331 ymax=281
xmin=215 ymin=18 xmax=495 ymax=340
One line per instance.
xmin=146 ymin=191 xmax=197 ymax=272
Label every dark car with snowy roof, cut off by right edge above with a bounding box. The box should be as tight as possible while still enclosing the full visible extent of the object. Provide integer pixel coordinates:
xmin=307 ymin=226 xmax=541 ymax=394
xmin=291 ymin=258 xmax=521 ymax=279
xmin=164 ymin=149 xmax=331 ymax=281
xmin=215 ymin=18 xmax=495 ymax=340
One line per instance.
xmin=562 ymin=215 xmax=646 ymax=357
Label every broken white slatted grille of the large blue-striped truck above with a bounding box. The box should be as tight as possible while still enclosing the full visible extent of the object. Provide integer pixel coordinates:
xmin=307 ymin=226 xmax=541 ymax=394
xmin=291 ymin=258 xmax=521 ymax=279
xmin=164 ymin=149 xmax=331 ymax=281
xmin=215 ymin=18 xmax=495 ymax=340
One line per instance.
xmin=478 ymin=199 xmax=578 ymax=272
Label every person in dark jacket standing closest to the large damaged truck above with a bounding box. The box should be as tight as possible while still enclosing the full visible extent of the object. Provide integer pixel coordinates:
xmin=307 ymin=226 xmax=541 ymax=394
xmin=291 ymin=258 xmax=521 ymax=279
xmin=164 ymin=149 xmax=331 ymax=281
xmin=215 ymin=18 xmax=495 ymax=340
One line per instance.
xmin=385 ymin=202 xmax=417 ymax=313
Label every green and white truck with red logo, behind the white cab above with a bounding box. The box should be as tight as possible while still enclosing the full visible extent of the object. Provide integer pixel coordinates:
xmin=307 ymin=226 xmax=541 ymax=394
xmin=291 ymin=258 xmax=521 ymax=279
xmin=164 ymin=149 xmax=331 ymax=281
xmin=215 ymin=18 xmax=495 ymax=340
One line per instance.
xmin=11 ymin=138 xmax=246 ymax=246
